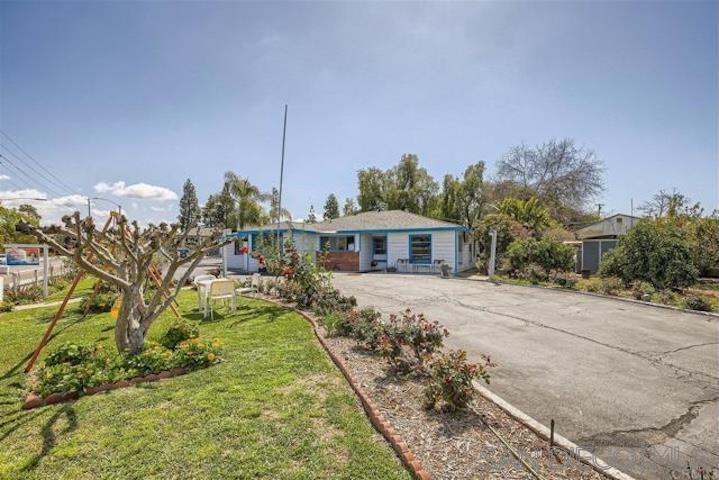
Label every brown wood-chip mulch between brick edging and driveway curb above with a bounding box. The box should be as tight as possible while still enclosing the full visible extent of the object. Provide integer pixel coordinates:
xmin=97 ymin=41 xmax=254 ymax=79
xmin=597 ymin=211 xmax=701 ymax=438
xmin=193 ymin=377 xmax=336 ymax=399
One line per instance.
xmin=325 ymin=337 xmax=606 ymax=480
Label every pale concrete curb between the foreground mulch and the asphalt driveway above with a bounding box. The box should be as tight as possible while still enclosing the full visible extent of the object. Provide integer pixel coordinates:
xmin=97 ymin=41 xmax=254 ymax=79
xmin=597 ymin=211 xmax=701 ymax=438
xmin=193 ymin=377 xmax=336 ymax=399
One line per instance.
xmin=472 ymin=381 xmax=635 ymax=480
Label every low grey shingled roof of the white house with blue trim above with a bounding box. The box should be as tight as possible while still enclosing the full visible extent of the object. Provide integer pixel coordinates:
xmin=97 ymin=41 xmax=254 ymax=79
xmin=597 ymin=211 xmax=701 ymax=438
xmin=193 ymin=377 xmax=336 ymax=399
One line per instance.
xmin=233 ymin=210 xmax=465 ymax=234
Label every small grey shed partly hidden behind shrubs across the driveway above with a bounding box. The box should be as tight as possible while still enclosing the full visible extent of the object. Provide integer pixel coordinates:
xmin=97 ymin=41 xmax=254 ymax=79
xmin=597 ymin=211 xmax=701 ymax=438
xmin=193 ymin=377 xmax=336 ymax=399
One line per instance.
xmin=574 ymin=213 xmax=640 ymax=273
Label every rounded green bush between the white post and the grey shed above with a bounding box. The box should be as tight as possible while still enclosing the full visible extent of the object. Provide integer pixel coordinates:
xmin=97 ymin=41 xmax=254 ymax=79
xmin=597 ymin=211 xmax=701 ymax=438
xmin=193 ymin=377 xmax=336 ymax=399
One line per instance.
xmin=505 ymin=238 xmax=575 ymax=273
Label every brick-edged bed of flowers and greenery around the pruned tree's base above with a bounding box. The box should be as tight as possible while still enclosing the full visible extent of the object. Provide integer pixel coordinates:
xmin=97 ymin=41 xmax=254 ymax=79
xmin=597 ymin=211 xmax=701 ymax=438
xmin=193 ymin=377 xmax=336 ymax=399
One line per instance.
xmin=23 ymin=326 xmax=221 ymax=409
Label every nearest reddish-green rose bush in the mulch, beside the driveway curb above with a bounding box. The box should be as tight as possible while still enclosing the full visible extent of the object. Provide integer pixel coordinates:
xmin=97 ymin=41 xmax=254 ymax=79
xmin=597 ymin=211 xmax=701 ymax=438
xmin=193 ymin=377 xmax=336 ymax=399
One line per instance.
xmin=425 ymin=350 xmax=493 ymax=410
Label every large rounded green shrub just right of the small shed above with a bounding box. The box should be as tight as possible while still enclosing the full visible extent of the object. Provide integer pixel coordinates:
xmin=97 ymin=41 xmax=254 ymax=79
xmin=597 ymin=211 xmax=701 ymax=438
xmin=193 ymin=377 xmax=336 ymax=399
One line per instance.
xmin=600 ymin=220 xmax=698 ymax=290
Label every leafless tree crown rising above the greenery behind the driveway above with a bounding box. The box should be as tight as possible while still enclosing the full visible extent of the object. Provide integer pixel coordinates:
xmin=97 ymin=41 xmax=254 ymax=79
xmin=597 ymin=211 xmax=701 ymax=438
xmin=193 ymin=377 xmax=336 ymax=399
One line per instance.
xmin=497 ymin=138 xmax=604 ymax=218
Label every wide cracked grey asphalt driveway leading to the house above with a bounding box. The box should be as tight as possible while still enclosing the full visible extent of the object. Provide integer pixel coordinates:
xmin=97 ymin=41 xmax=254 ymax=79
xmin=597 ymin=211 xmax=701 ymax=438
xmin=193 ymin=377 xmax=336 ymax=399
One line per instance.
xmin=335 ymin=274 xmax=719 ymax=479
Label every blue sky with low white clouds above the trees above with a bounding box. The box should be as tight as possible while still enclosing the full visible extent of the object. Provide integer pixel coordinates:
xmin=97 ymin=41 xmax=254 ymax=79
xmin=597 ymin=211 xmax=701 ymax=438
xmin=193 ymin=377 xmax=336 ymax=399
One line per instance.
xmin=0 ymin=2 xmax=719 ymax=225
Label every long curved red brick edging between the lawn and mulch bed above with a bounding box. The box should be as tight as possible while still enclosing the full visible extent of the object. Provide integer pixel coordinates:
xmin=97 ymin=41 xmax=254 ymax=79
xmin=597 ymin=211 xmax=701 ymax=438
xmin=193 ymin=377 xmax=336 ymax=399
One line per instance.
xmin=258 ymin=296 xmax=432 ymax=480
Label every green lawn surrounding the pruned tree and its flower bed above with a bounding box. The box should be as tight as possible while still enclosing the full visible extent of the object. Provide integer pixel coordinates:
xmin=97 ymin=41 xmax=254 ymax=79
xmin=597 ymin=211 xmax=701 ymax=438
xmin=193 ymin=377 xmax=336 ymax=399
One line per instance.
xmin=0 ymin=291 xmax=410 ymax=479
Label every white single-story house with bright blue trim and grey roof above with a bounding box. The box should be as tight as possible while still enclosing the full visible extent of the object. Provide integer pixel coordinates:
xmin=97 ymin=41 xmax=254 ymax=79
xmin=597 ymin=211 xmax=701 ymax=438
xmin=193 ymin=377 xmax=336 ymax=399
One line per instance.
xmin=224 ymin=210 xmax=474 ymax=273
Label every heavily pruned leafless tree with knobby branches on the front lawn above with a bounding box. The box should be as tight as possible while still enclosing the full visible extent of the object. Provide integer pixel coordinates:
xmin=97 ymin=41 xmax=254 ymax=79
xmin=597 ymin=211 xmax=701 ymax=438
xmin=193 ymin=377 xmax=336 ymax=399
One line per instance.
xmin=20 ymin=212 xmax=229 ymax=355
